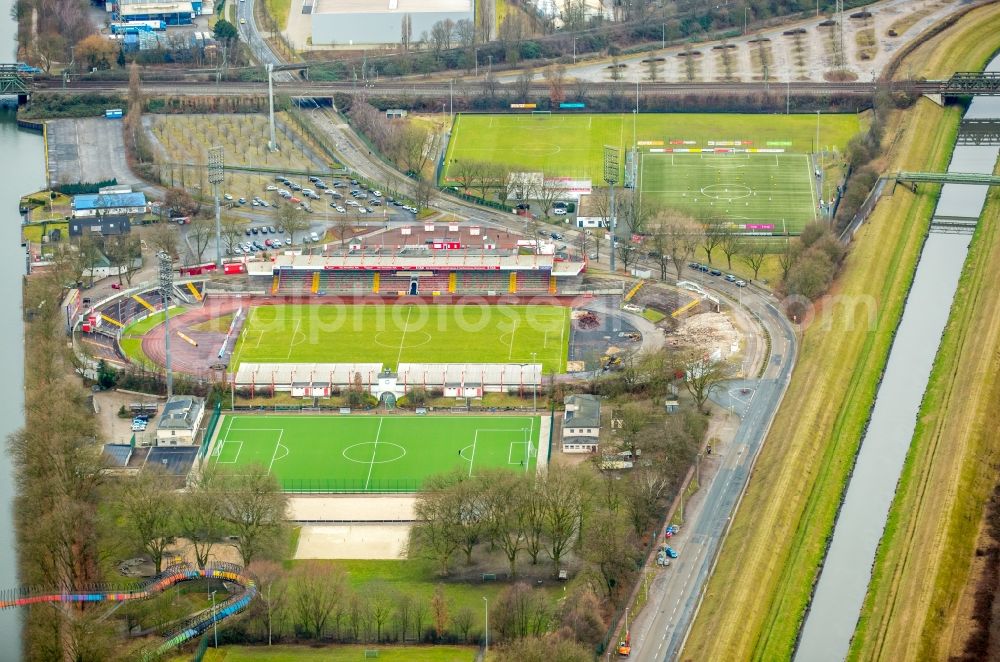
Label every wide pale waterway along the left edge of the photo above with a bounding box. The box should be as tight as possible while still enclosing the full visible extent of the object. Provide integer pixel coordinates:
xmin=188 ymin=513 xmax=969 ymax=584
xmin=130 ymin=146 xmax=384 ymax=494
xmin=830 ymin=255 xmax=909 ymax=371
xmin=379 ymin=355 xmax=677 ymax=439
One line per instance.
xmin=0 ymin=0 xmax=45 ymax=662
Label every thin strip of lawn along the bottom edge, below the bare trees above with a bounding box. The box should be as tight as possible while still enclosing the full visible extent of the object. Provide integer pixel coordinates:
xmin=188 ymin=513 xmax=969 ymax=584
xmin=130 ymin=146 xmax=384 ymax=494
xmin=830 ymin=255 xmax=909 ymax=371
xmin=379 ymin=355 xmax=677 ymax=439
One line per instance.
xmin=197 ymin=644 xmax=477 ymax=662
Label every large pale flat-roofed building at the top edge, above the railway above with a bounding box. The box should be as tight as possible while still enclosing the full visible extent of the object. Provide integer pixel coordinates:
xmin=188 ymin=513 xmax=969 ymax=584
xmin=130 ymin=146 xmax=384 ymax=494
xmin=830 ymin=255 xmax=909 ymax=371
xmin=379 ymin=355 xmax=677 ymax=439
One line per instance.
xmin=311 ymin=0 xmax=475 ymax=46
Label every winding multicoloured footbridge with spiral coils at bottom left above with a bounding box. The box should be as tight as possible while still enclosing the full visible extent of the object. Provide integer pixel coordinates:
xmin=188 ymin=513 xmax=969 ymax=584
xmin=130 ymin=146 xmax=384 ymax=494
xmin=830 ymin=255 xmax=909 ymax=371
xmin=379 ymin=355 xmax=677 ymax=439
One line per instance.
xmin=0 ymin=563 xmax=257 ymax=657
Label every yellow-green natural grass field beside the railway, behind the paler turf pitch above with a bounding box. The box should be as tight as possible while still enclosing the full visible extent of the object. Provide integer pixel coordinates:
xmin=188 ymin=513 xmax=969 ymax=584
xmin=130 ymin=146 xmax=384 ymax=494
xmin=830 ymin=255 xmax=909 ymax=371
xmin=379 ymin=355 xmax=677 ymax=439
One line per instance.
xmin=442 ymin=113 xmax=860 ymax=185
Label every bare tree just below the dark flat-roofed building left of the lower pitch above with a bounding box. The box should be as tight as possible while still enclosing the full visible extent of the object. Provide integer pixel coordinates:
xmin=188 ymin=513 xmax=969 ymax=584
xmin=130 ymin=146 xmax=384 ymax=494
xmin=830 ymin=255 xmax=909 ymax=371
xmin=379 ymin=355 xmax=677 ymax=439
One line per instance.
xmin=119 ymin=469 xmax=178 ymax=573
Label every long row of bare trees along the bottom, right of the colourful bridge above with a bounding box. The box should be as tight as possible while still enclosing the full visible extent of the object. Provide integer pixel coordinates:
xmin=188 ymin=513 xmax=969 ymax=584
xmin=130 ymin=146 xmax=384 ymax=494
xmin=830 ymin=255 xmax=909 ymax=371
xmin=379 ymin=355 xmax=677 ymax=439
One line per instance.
xmin=227 ymin=561 xmax=606 ymax=659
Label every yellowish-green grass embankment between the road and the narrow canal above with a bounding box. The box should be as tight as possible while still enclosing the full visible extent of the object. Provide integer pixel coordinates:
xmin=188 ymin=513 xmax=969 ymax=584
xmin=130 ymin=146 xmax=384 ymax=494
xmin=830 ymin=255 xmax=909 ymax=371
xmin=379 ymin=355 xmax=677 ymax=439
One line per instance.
xmin=684 ymin=96 xmax=960 ymax=660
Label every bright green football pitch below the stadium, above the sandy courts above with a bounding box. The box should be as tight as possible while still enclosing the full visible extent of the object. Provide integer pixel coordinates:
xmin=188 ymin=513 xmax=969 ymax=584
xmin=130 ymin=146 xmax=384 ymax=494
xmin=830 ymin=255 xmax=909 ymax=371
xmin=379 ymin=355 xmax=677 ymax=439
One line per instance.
xmin=211 ymin=415 xmax=547 ymax=492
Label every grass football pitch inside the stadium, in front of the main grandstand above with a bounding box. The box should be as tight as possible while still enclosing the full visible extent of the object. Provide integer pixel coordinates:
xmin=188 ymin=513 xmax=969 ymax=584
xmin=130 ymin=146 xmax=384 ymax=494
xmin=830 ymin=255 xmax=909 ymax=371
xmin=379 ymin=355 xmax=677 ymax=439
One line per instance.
xmin=233 ymin=304 xmax=570 ymax=372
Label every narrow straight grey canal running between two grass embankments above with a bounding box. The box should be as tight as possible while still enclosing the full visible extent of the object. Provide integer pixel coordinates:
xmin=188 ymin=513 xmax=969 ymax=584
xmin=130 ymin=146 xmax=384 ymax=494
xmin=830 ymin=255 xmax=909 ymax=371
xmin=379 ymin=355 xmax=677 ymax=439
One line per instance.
xmin=795 ymin=57 xmax=1000 ymax=662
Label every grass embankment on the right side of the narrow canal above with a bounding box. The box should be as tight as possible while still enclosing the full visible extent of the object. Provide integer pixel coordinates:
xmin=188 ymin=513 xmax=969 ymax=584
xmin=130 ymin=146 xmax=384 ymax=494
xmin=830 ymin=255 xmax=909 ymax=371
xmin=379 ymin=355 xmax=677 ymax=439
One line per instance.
xmin=851 ymin=174 xmax=1000 ymax=660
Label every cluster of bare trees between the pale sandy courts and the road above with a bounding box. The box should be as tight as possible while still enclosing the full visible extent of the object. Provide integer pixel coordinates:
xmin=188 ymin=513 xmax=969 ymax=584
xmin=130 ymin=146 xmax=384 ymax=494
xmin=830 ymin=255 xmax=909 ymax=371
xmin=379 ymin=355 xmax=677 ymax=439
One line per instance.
xmin=410 ymin=403 xmax=704 ymax=599
